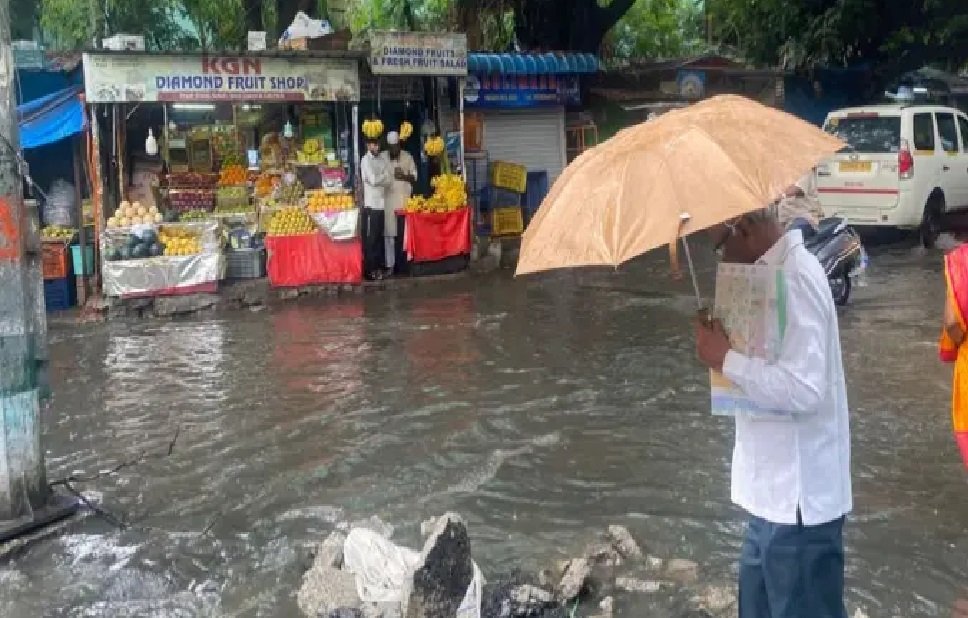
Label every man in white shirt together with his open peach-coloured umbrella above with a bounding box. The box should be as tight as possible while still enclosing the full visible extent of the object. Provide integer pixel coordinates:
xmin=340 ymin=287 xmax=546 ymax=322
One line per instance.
xmin=516 ymin=95 xmax=852 ymax=618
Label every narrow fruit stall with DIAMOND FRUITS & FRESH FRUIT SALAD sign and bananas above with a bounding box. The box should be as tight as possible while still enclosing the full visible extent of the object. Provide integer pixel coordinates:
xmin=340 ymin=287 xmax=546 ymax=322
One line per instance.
xmin=361 ymin=31 xmax=471 ymax=275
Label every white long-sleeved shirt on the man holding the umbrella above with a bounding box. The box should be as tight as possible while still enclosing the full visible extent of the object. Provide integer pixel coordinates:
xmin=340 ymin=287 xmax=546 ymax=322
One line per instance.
xmin=723 ymin=230 xmax=852 ymax=526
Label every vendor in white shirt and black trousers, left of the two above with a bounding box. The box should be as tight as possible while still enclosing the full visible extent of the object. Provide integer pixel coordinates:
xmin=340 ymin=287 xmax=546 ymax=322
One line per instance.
xmin=360 ymin=138 xmax=395 ymax=280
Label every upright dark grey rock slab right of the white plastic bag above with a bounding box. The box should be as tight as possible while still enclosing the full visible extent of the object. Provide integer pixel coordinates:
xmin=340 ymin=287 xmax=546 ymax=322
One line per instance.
xmin=404 ymin=513 xmax=474 ymax=618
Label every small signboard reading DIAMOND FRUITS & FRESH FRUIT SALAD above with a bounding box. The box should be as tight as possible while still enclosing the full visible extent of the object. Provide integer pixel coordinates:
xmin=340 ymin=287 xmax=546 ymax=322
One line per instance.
xmin=370 ymin=31 xmax=467 ymax=77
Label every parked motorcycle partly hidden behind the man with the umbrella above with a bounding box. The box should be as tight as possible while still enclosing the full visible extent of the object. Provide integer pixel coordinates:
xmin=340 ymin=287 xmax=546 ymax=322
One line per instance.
xmin=790 ymin=217 xmax=867 ymax=307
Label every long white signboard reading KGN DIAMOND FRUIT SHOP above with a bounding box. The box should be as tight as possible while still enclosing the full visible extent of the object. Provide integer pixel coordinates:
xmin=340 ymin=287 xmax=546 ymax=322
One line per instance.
xmin=84 ymin=53 xmax=360 ymax=103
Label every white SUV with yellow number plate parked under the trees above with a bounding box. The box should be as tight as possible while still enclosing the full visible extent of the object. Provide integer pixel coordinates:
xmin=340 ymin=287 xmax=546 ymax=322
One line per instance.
xmin=816 ymin=105 xmax=968 ymax=246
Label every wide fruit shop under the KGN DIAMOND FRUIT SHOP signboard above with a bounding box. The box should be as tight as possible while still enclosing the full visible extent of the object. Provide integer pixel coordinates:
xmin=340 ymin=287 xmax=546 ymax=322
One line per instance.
xmin=78 ymin=51 xmax=363 ymax=297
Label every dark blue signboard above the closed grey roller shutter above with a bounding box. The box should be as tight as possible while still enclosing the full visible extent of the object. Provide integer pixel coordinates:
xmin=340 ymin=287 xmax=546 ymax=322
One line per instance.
xmin=464 ymin=75 xmax=581 ymax=109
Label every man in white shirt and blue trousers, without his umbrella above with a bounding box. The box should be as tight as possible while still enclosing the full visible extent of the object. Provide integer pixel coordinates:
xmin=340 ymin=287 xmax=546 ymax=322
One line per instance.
xmin=696 ymin=205 xmax=852 ymax=618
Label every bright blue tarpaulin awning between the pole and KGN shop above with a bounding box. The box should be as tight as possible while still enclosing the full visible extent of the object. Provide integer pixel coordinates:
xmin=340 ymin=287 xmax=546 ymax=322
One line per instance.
xmin=17 ymin=87 xmax=85 ymax=149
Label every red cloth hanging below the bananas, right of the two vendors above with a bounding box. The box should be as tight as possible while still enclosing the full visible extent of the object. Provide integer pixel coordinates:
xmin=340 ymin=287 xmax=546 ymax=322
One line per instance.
xmin=403 ymin=208 xmax=471 ymax=262
